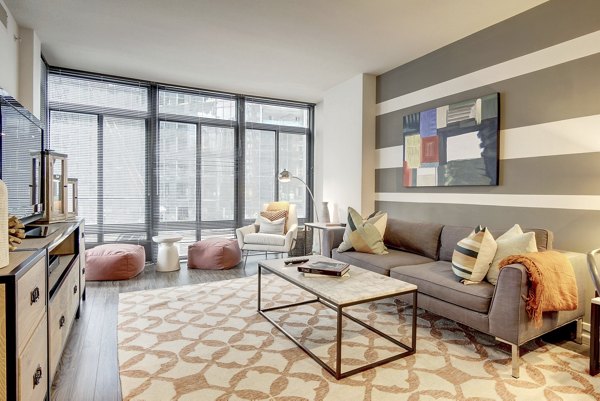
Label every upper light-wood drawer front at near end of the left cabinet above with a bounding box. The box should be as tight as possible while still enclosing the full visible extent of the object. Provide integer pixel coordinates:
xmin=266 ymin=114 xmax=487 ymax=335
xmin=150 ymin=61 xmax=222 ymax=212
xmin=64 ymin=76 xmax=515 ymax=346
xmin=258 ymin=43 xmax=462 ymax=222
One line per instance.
xmin=17 ymin=257 xmax=46 ymax=352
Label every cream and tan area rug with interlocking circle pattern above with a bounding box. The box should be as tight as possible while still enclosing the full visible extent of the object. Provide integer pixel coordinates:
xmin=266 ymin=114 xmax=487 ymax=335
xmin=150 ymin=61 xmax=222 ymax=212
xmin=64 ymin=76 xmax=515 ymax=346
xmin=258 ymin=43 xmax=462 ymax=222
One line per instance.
xmin=118 ymin=276 xmax=600 ymax=401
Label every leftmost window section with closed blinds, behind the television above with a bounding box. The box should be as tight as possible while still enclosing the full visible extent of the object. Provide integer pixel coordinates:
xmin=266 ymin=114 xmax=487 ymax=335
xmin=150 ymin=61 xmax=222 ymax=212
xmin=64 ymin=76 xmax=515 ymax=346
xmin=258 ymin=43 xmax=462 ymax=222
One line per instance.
xmin=48 ymin=74 xmax=149 ymax=247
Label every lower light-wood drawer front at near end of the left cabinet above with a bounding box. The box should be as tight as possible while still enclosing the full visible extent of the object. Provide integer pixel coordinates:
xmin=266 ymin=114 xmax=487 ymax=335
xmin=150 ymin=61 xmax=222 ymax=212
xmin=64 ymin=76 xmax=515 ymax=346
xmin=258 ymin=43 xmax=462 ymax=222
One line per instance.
xmin=18 ymin=314 xmax=48 ymax=401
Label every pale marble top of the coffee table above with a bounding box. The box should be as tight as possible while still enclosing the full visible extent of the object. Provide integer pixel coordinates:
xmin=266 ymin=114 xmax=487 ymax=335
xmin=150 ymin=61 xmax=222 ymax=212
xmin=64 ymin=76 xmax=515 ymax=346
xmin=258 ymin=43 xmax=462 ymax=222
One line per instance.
xmin=258 ymin=255 xmax=417 ymax=306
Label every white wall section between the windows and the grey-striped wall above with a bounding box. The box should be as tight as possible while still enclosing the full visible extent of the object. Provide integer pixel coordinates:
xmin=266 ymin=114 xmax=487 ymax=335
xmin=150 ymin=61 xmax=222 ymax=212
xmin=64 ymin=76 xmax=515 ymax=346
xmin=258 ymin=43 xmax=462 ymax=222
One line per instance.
xmin=315 ymin=74 xmax=375 ymax=222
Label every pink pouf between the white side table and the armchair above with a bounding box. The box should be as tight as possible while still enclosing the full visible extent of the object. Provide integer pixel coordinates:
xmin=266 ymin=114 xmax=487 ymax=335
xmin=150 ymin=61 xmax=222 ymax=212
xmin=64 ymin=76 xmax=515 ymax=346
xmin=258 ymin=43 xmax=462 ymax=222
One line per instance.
xmin=188 ymin=238 xmax=242 ymax=270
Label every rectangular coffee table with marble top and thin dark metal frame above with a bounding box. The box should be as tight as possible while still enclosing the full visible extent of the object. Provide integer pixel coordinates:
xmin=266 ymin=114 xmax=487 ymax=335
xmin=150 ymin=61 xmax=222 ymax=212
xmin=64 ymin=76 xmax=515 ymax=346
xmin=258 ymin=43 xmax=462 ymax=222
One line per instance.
xmin=258 ymin=256 xmax=417 ymax=380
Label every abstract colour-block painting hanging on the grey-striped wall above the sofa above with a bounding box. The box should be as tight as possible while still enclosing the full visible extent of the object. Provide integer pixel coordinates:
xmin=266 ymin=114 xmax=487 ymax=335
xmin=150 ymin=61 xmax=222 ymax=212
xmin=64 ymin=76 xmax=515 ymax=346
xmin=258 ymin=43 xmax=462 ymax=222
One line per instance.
xmin=402 ymin=93 xmax=499 ymax=187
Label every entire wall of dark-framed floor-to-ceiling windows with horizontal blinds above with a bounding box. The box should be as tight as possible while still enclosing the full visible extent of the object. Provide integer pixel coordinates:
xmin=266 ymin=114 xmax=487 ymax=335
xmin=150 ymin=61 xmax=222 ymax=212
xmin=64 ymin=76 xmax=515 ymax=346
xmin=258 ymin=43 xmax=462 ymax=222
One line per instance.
xmin=48 ymin=68 xmax=312 ymax=255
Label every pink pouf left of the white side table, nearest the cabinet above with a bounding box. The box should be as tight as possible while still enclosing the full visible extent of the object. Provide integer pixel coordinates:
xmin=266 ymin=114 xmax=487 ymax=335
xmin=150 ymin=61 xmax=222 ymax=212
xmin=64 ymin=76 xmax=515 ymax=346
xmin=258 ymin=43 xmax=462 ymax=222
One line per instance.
xmin=85 ymin=244 xmax=146 ymax=281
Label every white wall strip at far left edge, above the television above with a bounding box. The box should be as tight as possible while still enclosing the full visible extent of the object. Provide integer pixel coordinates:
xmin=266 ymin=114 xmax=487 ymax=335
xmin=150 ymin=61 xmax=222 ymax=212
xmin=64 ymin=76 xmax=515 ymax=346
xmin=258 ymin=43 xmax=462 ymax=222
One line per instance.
xmin=0 ymin=0 xmax=19 ymax=99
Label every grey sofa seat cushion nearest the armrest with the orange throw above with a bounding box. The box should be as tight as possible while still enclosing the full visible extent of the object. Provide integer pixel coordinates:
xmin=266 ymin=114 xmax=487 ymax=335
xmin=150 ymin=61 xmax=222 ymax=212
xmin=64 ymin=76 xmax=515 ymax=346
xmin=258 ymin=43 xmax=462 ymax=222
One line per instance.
xmin=390 ymin=261 xmax=494 ymax=313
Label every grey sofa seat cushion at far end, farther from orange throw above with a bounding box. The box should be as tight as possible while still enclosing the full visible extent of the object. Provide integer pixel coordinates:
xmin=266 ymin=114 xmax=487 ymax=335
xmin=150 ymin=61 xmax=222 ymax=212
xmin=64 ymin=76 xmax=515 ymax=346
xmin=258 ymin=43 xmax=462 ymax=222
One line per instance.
xmin=331 ymin=249 xmax=433 ymax=276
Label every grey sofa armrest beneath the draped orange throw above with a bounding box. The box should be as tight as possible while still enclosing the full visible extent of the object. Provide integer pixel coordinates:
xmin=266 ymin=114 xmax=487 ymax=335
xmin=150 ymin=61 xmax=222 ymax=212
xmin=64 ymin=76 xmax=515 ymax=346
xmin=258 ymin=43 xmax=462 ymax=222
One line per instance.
xmin=489 ymin=251 xmax=590 ymax=345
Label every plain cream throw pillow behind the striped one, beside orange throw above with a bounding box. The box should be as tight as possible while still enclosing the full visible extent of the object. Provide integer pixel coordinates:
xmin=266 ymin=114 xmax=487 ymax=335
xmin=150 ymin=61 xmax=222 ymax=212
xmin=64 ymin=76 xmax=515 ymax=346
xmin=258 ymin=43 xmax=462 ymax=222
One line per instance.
xmin=485 ymin=224 xmax=538 ymax=285
